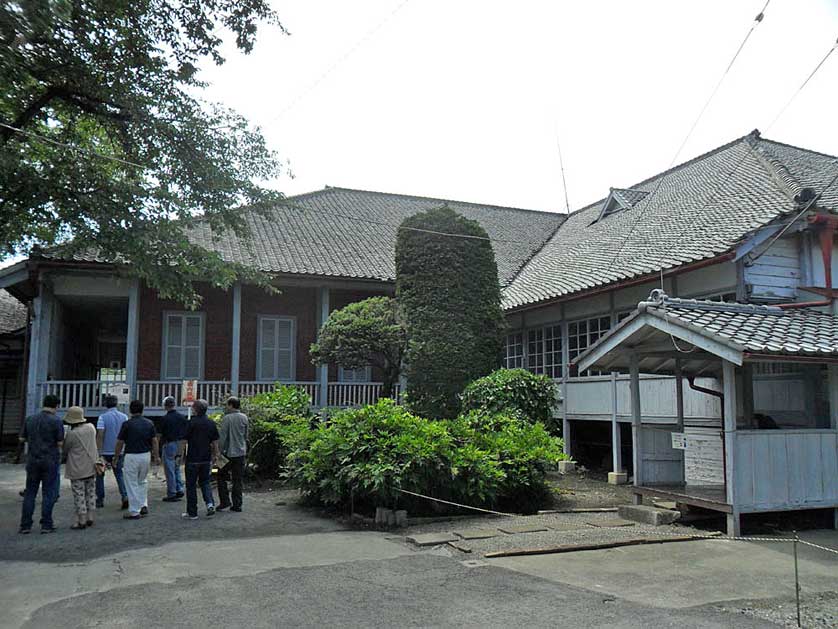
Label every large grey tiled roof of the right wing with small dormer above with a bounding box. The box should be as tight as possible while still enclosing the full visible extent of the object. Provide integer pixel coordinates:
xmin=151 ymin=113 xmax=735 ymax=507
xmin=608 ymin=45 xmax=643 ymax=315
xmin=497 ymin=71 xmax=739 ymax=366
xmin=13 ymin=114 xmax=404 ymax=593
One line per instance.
xmin=504 ymin=133 xmax=838 ymax=308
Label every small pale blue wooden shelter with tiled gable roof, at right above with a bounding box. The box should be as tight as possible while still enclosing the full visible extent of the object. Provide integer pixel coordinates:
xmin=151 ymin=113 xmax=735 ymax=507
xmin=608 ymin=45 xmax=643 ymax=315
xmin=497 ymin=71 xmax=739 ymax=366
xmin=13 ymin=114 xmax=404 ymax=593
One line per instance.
xmin=575 ymin=291 xmax=838 ymax=535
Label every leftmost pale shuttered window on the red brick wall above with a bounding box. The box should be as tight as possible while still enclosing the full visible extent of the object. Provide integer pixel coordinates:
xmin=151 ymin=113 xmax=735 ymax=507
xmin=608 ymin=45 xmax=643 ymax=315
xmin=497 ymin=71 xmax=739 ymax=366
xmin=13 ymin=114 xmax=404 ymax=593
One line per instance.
xmin=162 ymin=312 xmax=204 ymax=380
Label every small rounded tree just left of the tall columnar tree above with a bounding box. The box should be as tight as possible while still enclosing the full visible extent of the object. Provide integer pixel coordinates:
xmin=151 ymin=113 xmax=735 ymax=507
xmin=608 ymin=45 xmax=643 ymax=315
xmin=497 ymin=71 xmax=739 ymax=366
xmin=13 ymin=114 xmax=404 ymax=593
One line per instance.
xmin=310 ymin=297 xmax=405 ymax=397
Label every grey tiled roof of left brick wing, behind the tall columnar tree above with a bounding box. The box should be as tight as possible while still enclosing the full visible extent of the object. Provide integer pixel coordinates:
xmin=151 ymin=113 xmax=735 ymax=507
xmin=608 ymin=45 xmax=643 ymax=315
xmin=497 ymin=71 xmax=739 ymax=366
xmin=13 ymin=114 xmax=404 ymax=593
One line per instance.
xmin=42 ymin=187 xmax=565 ymax=285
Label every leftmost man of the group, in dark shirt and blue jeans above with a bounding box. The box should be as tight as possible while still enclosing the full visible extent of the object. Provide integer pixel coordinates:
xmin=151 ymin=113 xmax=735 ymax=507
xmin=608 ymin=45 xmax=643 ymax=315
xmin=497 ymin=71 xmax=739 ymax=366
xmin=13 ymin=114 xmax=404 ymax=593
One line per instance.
xmin=20 ymin=395 xmax=64 ymax=534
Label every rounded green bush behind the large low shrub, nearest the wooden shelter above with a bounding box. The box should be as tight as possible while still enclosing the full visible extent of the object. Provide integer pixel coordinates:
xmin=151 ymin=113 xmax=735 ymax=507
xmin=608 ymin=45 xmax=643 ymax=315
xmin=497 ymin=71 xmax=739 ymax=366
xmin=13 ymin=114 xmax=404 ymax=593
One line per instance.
xmin=462 ymin=369 xmax=558 ymax=434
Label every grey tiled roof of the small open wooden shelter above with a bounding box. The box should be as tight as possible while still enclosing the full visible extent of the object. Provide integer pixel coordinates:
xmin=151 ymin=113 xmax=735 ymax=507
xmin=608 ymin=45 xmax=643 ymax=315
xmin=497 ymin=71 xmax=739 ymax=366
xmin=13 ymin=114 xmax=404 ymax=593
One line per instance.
xmin=641 ymin=298 xmax=838 ymax=356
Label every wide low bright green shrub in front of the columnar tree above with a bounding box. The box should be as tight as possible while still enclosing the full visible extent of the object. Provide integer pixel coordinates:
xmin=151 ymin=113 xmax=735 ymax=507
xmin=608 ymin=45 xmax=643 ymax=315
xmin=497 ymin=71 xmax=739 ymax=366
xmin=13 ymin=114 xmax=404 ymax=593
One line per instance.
xmin=288 ymin=399 xmax=564 ymax=512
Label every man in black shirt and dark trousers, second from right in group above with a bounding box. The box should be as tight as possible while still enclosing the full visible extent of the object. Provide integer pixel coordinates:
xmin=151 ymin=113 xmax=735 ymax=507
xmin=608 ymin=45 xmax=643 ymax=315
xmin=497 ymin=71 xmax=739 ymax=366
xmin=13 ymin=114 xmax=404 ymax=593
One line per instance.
xmin=180 ymin=400 xmax=218 ymax=520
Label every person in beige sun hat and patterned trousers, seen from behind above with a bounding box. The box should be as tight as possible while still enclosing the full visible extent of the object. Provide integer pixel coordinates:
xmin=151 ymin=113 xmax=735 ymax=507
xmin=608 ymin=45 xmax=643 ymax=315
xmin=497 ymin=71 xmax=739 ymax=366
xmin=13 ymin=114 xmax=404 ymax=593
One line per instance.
xmin=64 ymin=406 xmax=99 ymax=531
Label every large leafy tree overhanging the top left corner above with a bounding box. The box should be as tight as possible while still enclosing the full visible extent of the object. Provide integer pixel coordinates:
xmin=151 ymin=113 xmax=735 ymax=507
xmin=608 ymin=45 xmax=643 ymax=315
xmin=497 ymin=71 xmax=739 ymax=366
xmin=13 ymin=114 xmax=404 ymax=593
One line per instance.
xmin=0 ymin=0 xmax=282 ymax=303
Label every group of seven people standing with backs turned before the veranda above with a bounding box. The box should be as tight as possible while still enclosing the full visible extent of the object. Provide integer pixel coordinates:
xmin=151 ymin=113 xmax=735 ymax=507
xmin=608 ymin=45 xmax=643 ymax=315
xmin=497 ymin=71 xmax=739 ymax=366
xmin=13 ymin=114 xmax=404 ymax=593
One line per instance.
xmin=20 ymin=395 xmax=248 ymax=534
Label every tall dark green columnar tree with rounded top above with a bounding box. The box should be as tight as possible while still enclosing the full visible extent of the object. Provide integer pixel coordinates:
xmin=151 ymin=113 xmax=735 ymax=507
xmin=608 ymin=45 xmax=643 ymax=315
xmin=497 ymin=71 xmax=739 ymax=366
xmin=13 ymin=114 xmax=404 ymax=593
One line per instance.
xmin=396 ymin=207 xmax=504 ymax=418
